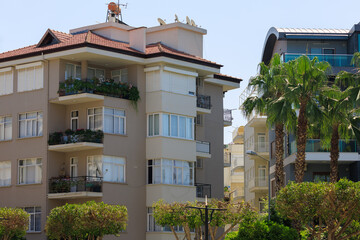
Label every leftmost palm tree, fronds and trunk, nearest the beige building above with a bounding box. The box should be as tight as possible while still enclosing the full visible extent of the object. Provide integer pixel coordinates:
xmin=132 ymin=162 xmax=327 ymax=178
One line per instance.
xmin=243 ymin=54 xmax=296 ymax=192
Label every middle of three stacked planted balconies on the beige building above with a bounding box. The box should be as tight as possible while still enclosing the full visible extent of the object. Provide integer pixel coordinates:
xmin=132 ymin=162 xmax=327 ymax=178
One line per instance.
xmin=48 ymin=129 xmax=104 ymax=152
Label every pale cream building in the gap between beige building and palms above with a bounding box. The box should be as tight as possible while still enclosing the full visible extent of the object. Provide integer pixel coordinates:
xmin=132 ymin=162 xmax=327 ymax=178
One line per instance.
xmin=224 ymin=126 xmax=244 ymax=202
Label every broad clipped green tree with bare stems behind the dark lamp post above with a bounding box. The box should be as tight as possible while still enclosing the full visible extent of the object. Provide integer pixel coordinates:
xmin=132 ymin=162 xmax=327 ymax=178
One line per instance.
xmin=153 ymin=199 xmax=256 ymax=240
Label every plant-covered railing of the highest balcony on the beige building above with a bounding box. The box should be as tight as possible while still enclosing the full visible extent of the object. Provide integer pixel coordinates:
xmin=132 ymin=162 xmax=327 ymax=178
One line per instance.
xmin=58 ymin=79 xmax=140 ymax=102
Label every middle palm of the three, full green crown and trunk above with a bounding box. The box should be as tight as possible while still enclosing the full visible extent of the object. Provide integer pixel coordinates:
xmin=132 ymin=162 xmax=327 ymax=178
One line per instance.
xmin=284 ymin=55 xmax=330 ymax=182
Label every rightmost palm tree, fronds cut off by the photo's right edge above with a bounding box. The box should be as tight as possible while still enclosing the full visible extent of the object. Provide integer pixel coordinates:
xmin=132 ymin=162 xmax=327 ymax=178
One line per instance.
xmin=320 ymin=58 xmax=360 ymax=182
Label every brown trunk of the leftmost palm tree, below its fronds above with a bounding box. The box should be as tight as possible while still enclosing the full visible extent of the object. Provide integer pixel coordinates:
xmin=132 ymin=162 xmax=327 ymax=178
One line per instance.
xmin=276 ymin=123 xmax=285 ymax=193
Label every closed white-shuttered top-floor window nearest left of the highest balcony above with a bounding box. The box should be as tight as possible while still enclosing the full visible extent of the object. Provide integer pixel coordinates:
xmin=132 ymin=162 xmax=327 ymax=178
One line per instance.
xmin=16 ymin=62 xmax=44 ymax=92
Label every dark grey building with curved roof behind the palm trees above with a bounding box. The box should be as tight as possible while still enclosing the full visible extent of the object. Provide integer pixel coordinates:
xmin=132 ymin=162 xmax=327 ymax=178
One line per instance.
xmin=262 ymin=24 xmax=360 ymax=196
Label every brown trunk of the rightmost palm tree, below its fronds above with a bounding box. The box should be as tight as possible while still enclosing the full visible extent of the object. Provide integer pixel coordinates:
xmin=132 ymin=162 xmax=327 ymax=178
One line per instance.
xmin=330 ymin=124 xmax=339 ymax=183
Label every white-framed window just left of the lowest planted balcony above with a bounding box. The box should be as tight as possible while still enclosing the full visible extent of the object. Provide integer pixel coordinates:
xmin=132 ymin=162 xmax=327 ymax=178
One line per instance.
xmin=19 ymin=158 xmax=42 ymax=184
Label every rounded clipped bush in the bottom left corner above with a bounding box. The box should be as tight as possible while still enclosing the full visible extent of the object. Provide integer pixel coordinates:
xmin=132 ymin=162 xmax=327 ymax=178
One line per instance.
xmin=0 ymin=208 xmax=29 ymax=240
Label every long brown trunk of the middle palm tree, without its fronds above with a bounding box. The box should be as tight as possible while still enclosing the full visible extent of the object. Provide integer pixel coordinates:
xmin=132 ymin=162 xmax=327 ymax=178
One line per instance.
xmin=295 ymin=98 xmax=307 ymax=183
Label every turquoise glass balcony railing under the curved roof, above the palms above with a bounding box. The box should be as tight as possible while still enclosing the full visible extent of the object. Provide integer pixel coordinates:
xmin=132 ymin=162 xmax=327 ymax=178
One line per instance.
xmin=283 ymin=53 xmax=354 ymax=67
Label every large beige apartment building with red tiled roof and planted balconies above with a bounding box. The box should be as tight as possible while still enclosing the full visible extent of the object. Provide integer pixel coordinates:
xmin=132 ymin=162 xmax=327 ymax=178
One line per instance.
xmin=0 ymin=11 xmax=241 ymax=240
